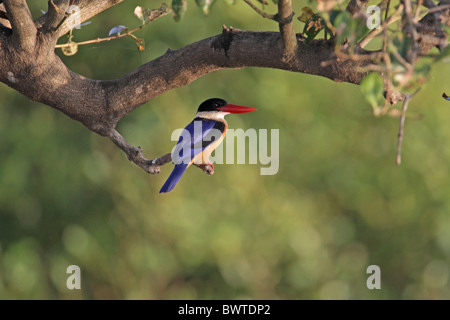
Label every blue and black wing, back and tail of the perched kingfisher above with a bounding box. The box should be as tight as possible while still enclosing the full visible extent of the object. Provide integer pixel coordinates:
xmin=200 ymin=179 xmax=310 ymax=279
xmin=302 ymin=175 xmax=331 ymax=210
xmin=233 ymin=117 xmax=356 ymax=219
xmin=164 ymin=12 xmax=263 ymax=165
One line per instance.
xmin=159 ymin=119 xmax=217 ymax=193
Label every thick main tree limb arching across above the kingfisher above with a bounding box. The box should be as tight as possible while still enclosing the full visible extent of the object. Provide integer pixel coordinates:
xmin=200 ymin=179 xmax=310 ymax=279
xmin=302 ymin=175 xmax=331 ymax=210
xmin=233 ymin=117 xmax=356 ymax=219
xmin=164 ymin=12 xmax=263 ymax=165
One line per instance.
xmin=0 ymin=29 xmax=371 ymax=136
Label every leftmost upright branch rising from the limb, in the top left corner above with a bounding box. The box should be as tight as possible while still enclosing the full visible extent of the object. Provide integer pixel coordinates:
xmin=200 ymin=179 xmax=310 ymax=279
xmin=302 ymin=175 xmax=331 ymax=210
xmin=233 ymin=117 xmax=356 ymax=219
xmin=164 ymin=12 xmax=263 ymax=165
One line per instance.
xmin=3 ymin=0 xmax=37 ymax=52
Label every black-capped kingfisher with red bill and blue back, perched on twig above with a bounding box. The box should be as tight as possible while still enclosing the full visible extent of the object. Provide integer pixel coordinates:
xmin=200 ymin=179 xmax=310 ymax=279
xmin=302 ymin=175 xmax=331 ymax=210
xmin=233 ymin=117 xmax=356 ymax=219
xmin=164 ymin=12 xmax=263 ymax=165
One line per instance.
xmin=159 ymin=98 xmax=256 ymax=193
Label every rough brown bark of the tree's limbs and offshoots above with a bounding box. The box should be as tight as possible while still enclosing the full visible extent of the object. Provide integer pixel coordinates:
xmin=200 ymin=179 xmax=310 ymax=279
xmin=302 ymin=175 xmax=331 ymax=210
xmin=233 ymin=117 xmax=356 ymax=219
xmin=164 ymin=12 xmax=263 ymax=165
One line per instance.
xmin=0 ymin=0 xmax=450 ymax=173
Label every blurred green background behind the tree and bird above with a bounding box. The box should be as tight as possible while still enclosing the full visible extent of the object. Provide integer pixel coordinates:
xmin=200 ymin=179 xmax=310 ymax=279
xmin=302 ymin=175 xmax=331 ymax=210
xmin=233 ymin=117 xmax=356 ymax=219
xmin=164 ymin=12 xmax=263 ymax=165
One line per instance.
xmin=0 ymin=0 xmax=450 ymax=299
